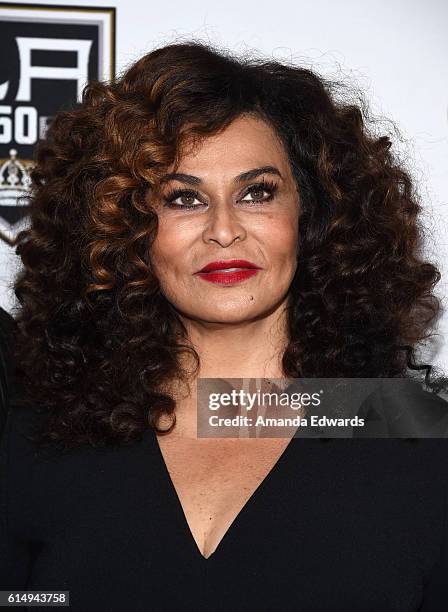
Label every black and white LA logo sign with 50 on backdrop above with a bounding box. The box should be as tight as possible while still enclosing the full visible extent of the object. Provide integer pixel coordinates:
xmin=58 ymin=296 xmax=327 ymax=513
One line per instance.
xmin=0 ymin=3 xmax=115 ymax=244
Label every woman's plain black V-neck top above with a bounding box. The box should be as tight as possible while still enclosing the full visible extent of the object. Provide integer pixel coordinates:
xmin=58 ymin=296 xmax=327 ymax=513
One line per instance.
xmin=0 ymin=408 xmax=448 ymax=612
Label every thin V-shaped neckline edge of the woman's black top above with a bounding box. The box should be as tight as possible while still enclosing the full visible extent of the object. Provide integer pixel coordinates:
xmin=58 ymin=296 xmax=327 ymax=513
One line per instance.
xmin=150 ymin=428 xmax=295 ymax=563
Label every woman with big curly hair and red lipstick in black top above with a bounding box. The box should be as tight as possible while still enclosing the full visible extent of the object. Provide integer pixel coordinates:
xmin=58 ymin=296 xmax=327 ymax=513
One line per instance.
xmin=0 ymin=43 xmax=448 ymax=612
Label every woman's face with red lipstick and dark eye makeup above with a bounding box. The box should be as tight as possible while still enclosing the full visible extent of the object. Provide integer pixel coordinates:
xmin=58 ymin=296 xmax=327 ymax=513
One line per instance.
xmin=151 ymin=116 xmax=299 ymax=323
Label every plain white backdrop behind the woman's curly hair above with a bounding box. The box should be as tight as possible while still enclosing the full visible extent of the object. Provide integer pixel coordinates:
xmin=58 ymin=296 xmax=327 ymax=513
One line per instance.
xmin=0 ymin=0 xmax=448 ymax=369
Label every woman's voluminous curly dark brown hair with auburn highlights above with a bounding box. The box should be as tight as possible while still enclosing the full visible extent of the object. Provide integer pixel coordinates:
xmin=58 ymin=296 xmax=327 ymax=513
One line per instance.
xmin=15 ymin=41 xmax=441 ymax=448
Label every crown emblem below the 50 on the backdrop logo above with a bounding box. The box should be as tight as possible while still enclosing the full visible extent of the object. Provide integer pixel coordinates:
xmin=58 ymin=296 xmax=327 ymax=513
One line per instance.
xmin=0 ymin=149 xmax=34 ymax=245
